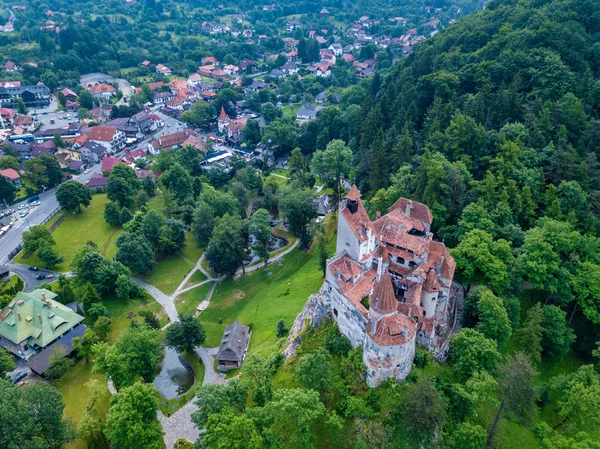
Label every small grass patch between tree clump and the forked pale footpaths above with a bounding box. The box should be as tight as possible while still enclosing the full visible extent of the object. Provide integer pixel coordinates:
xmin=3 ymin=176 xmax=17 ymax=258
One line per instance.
xmin=143 ymin=233 xmax=204 ymax=295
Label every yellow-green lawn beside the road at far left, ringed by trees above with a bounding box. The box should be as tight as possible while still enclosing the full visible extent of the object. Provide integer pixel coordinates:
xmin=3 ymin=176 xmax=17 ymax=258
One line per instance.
xmin=15 ymin=194 xmax=120 ymax=272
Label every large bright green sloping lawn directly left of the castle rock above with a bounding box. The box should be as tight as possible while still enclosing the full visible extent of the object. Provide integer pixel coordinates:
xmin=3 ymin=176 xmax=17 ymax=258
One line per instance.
xmin=200 ymin=222 xmax=335 ymax=354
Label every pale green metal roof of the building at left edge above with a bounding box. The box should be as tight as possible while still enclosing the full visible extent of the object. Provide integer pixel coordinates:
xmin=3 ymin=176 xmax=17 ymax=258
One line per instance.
xmin=0 ymin=289 xmax=83 ymax=356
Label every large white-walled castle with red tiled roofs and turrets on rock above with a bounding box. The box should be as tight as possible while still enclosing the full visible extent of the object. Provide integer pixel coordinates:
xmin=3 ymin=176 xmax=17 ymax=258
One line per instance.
xmin=319 ymin=186 xmax=456 ymax=387
